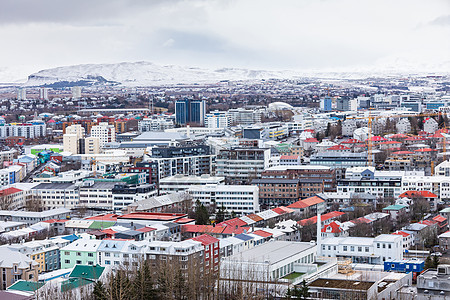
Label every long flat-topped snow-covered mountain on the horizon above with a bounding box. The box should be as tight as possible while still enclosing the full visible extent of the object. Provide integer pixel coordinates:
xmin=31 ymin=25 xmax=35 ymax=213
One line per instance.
xmin=25 ymin=62 xmax=295 ymax=86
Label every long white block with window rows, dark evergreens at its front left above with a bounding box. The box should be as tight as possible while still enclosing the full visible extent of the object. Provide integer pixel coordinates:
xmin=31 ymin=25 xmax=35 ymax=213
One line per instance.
xmin=187 ymin=184 xmax=259 ymax=215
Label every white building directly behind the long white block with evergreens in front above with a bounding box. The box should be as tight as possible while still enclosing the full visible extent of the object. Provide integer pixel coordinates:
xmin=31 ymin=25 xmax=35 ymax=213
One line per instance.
xmin=159 ymin=174 xmax=225 ymax=195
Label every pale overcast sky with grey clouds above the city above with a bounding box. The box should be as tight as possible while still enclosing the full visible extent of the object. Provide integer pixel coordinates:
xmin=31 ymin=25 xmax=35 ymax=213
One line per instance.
xmin=0 ymin=0 xmax=450 ymax=79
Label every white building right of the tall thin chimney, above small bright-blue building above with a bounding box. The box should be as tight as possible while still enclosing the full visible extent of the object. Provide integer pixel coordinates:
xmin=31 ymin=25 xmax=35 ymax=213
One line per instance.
xmin=318 ymin=234 xmax=403 ymax=264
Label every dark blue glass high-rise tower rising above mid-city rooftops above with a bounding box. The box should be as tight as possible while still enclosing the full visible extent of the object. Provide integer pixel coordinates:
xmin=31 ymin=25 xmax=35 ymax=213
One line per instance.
xmin=175 ymin=99 xmax=206 ymax=126
